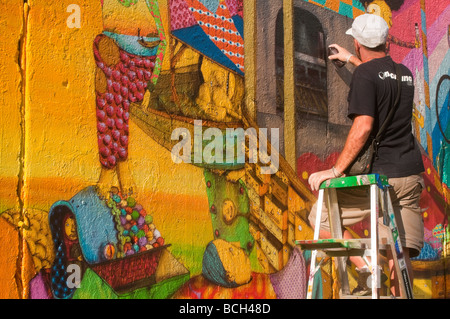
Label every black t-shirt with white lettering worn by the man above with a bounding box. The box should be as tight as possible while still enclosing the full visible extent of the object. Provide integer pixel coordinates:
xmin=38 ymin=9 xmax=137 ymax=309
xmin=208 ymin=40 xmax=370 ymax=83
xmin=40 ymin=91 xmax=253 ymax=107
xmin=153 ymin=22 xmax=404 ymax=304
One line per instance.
xmin=348 ymin=56 xmax=424 ymax=178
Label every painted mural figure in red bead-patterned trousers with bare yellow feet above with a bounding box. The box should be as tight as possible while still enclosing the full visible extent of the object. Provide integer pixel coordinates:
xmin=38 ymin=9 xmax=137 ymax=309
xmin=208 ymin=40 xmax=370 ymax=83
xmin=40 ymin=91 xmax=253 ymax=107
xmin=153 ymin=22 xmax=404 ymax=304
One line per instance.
xmin=93 ymin=0 xmax=166 ymax=198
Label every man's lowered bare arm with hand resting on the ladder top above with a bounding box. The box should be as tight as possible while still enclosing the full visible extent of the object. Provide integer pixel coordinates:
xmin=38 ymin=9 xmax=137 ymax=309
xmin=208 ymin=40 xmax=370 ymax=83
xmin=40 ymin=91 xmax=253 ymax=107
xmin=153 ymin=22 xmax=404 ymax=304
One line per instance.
xmin=308 ymin=115 xmax=374 ymax=191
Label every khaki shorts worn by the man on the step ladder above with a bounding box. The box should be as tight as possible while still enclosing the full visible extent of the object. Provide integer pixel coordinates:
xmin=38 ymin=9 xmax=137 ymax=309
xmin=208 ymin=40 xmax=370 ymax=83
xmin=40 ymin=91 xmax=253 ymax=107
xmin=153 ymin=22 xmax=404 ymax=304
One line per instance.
xmin=308 ymin=175 xmax=425 ymax=257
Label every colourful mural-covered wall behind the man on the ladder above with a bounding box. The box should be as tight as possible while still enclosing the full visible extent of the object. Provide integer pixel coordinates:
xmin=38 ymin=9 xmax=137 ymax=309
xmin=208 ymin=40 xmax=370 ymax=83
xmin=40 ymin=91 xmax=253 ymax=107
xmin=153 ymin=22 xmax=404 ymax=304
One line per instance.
xmin=0 ymin=0 xmax=450 ymax=299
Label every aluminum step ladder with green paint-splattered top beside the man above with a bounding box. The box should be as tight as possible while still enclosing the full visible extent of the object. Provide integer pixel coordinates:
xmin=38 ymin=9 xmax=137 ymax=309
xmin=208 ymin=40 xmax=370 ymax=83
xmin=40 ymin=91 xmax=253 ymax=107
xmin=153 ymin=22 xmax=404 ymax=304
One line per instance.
xmin=296 ymin=174 xmax=413 ymax=299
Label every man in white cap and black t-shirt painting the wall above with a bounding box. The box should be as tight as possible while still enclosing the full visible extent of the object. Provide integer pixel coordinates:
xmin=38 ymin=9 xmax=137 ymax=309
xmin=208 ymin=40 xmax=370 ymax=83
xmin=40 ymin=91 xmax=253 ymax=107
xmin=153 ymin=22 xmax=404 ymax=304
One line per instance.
xmin=309 ymin=14 xmax=424 ymax=295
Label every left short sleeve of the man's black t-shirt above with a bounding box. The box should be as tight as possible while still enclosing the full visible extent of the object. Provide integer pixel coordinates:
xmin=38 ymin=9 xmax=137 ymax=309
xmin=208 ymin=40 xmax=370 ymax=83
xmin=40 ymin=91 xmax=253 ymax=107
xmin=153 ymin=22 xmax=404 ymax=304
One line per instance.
xmin=347 ymin=67 xmax=377 ymax=119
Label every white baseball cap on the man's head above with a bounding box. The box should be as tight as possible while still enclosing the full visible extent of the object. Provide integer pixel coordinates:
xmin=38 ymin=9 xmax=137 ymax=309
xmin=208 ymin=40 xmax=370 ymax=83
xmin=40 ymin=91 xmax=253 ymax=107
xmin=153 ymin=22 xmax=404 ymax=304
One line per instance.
xmin=345 ymin=13 xmax=389 ymax=48
